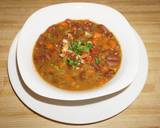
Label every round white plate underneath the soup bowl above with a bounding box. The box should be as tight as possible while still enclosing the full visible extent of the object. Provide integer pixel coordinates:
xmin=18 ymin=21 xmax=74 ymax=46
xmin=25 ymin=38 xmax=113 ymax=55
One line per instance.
xmin=8 ymin=29 xmax=148 ymax=124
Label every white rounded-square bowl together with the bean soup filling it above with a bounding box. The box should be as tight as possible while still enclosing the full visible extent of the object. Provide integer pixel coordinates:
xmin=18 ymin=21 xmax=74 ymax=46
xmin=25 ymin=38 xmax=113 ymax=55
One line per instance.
xmin=17 ymin=3 xmax=139 ymax=100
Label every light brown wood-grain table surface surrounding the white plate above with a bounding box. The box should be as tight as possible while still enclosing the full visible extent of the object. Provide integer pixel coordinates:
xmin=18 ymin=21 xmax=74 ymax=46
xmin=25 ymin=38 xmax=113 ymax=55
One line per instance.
xmin=0 ymin=0 xmax=160 ymax=128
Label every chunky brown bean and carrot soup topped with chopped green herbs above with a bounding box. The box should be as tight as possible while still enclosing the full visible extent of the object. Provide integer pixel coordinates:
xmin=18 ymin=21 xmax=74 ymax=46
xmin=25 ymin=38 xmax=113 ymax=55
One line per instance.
xmin=33 ymin=19 xmax=121 ymax=91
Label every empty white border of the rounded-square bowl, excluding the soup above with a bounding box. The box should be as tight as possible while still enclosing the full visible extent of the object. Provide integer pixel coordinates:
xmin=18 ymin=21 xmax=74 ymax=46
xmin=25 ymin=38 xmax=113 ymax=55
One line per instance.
xmin=17 ymin=3 xmax=139 ymax=100
